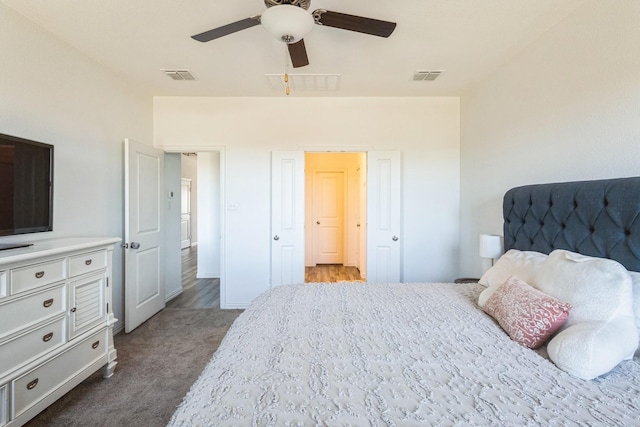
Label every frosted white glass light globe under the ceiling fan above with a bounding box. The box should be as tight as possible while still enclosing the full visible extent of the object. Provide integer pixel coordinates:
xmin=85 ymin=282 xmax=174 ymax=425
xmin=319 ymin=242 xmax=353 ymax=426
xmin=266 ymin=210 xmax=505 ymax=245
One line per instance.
xmin=260 ymin=5 xmax=315 ymax=44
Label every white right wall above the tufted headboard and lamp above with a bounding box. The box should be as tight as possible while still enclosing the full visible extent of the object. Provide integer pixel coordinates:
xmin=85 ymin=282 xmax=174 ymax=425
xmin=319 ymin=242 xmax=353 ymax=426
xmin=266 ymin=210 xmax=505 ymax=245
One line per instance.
xmin=460 ymin=0 xmax=640 ymax=276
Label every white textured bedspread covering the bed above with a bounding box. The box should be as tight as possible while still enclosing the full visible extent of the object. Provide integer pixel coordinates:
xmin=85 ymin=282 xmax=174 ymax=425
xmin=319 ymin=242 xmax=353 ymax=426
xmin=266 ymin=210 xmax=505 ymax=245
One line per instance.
xmin=169 ymin=283 xmax=640 ymax=426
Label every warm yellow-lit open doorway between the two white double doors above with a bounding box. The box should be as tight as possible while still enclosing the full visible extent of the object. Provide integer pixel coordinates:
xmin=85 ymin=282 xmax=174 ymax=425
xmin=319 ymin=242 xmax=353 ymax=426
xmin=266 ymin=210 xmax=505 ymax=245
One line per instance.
xmin=305 ymin=153 xmax=367 ymax=282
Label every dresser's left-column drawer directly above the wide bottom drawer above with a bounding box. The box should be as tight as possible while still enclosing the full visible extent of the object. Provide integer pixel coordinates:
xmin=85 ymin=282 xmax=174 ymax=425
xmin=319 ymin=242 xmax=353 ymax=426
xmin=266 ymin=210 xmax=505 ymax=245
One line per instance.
xmin=0 ymin=317 xmax=66 ymax=376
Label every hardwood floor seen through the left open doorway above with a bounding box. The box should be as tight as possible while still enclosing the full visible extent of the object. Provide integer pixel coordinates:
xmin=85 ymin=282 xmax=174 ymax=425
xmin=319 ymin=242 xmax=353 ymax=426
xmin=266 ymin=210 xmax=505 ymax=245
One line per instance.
xmin=167 ymin=246 xmax=220 ymax=308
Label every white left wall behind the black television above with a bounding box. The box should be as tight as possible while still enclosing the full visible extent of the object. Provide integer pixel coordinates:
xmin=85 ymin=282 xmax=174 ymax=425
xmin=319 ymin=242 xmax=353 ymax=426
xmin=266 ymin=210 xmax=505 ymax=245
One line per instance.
xmin=0 ymin=4 xmax=153 ymax=329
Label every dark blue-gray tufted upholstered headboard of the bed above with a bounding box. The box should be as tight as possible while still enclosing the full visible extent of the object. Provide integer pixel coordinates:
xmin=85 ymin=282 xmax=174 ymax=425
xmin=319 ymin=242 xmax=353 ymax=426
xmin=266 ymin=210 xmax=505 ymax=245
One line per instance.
xmin=503 ymin=177 xmax=640 ymax=271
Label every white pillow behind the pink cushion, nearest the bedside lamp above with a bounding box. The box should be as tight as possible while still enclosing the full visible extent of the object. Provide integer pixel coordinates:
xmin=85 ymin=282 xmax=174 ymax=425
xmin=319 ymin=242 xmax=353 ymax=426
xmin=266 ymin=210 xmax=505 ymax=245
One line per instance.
xmin=478 ymin=249 xmax=547 ymax=307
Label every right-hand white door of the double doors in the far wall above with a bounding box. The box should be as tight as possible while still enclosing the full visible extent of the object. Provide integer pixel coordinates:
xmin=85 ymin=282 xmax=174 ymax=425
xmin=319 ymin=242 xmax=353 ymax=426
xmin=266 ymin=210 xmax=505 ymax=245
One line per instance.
xmin=367 ymin=151 xmax=401 ymax=283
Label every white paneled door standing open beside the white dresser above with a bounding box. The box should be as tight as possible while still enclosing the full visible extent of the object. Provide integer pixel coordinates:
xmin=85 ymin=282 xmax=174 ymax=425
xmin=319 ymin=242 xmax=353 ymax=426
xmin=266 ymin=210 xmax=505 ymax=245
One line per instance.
xmin=124 ymin=139 xmax=165 ymax=332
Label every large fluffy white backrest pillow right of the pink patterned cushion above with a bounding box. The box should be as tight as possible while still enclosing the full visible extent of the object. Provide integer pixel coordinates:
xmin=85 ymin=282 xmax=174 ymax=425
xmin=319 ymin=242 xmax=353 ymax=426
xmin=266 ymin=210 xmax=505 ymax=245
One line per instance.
xmin=536 ymin=250 xmax=638 ymax=379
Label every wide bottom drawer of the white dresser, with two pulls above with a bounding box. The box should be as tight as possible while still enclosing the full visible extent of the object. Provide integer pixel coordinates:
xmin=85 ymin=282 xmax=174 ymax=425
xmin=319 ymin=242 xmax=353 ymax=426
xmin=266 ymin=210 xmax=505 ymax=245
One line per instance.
xmin=13 ymin=330 xmax=107 ymax=418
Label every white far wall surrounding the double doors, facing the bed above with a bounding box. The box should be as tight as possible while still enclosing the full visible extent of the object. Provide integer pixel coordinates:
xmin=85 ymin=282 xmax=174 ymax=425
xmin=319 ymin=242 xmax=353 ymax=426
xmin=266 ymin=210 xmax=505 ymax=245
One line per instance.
xmin=154 ymin=97 xmax=460 ymax=308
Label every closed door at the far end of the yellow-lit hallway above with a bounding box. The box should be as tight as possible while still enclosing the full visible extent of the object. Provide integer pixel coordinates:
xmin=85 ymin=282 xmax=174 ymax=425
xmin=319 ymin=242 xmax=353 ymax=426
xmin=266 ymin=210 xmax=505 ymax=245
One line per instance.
xmin=313 ymin=171 xmax=344 ymax=264
